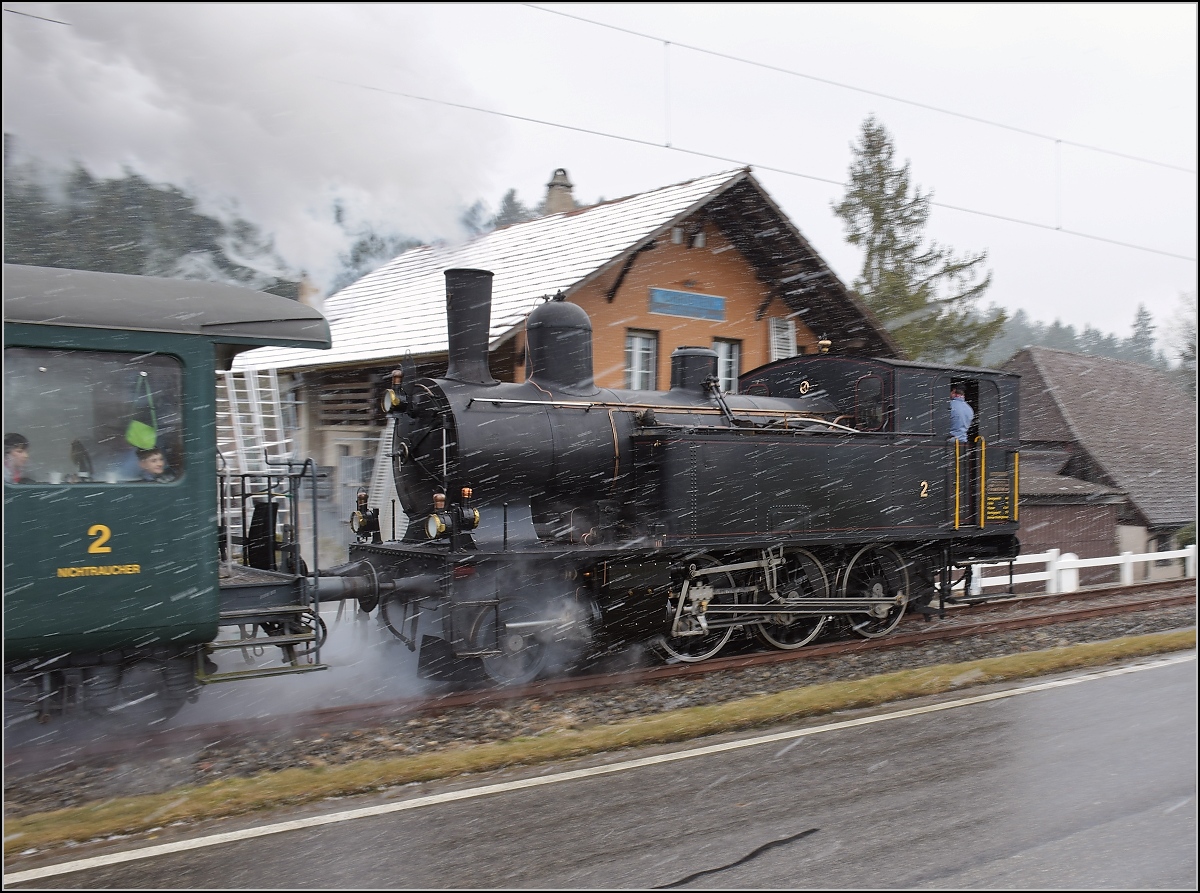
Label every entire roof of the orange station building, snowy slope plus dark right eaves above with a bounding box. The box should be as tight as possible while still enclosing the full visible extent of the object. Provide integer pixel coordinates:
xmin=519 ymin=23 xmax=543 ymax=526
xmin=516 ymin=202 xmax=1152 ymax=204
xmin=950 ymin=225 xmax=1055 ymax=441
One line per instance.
xmin=238 ymin=168 xmax=899 ymax=368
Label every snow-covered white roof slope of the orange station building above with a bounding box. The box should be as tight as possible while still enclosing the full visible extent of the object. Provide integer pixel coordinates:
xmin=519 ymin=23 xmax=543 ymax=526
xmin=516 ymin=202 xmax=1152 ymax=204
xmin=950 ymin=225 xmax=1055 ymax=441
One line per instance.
xmin=235 ymin=168 xmax=750 ymax=368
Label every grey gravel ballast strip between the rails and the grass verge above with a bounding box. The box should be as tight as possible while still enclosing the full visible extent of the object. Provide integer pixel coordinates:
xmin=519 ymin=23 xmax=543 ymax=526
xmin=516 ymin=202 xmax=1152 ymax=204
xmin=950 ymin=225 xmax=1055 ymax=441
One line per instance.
xmin=5 ymin=606 xmax=1196 ymax=817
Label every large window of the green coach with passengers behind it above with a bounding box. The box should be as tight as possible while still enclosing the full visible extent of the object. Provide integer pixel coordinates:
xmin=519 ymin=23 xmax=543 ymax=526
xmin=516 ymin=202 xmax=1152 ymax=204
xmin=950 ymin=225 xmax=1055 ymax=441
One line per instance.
xmin=4 ymin=347 xmax=184 ymax=484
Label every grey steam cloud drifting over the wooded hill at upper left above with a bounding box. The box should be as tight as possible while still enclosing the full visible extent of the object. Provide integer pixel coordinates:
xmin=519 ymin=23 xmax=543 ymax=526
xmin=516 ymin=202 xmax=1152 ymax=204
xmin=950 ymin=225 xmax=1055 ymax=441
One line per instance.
xmin=4 ymin=4 xmax=500 ymax=284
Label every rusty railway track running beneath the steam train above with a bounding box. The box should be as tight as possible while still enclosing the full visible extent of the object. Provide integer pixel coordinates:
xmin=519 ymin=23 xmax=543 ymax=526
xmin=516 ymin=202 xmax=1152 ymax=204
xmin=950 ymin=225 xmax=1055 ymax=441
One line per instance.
xmin=5 ymin=580 xmax=1196 ymax=774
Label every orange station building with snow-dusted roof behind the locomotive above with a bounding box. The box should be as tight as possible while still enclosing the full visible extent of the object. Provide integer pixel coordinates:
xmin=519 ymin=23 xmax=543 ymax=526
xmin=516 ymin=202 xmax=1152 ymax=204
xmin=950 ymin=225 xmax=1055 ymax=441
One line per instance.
xmin=230 ymin=168 xmax=902 ymax=541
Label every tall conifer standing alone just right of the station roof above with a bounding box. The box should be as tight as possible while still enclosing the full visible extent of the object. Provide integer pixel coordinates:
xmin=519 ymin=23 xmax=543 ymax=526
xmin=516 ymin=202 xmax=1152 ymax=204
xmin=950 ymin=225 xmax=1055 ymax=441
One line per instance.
xmin=833 ymin=116 xmax=1006 ymax=364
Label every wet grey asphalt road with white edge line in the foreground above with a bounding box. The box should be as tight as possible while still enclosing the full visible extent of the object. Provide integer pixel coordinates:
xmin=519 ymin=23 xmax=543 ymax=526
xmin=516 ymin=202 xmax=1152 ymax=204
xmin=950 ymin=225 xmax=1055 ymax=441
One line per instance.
xmin=5 ymin=653 xmax=1198 ymax=891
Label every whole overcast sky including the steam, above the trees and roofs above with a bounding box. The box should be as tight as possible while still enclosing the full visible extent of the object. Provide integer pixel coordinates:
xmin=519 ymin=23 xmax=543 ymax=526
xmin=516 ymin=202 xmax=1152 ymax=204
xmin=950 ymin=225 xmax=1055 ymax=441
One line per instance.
xmin=4 ymin=2 xmax=1198 ymax=352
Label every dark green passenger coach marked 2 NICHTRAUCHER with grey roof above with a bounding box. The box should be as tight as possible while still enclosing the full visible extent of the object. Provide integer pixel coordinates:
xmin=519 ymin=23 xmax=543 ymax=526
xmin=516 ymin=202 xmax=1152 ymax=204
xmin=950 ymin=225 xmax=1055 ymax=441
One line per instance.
xmin=4 ymin=264 xmax=330 ymax=712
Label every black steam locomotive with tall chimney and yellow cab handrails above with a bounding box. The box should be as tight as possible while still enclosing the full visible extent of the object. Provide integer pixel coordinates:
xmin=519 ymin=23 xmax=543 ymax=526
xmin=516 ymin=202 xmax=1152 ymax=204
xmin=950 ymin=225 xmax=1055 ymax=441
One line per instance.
xmin=336 ymin=270 xmax=1019 ymax=683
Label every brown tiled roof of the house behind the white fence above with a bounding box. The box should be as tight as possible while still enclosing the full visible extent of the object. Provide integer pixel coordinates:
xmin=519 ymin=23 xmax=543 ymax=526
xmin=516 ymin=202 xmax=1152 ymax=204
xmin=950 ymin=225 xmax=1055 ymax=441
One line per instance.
xmin=1004 ymin=347 xmax=1196 ymax=527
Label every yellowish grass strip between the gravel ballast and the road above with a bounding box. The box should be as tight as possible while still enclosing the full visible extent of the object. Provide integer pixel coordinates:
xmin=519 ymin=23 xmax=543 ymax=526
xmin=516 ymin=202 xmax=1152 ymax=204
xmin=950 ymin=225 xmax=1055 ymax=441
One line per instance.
xmin=4 ymin=629 xmax=1196 ymax=856
